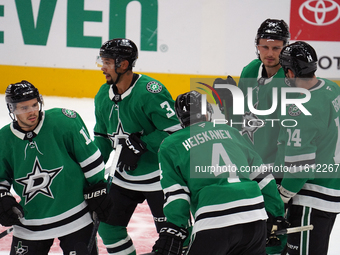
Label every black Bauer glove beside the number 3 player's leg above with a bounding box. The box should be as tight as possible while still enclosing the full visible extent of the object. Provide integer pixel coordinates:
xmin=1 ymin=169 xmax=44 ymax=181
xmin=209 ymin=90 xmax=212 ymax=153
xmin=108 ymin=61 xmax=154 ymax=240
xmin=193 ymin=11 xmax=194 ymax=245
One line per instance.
xmin=84 ymin=182 xmax=112 ymax=222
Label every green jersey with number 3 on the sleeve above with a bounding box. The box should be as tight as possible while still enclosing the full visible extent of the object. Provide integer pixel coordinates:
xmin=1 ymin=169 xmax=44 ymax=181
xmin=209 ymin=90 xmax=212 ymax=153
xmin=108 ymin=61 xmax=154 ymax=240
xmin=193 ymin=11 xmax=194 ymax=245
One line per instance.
xmin=94 ymin=74 xmax=181 ymax=191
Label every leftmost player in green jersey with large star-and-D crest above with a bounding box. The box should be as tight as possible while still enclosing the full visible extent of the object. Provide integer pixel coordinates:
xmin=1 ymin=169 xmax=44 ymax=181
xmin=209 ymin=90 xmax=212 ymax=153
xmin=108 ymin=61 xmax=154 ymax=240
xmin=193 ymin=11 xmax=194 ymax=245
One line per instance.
xmin=0 ymin=81 xmax=109 ymax=255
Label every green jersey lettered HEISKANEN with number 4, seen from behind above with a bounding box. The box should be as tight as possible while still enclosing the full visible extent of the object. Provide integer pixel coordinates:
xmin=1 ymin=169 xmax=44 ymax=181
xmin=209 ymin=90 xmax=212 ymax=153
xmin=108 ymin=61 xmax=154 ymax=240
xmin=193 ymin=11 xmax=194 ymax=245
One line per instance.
xmin=159 ymin=122 xmax=283 ymax=233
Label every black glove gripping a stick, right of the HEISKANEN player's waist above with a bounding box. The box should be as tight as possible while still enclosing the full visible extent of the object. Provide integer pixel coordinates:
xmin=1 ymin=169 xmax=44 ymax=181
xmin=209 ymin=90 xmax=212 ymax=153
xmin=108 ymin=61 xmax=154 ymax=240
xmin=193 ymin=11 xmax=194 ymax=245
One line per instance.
xmin=266 ymin=212 xmax=290 ymax=247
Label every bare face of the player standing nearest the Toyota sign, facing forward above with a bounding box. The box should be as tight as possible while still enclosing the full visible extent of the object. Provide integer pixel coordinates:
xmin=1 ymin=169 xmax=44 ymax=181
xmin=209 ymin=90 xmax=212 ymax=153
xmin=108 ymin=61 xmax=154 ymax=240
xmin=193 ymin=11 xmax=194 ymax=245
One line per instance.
xmin=257 ymin=39 xmax=283 ymax=67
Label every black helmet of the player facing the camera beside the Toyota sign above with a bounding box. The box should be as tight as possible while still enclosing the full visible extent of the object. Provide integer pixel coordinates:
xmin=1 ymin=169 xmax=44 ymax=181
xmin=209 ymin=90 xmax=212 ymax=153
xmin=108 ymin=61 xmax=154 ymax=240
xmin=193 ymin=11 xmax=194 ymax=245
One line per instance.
xmin=255 ymin=19 xmax=290 ymax=45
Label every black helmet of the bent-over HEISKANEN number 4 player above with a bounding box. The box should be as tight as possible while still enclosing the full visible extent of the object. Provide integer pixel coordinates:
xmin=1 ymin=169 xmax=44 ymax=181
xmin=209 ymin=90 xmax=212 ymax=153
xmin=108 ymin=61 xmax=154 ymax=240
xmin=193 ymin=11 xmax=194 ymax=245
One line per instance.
xmin=175 ymin=90 xmax=213 ymax=128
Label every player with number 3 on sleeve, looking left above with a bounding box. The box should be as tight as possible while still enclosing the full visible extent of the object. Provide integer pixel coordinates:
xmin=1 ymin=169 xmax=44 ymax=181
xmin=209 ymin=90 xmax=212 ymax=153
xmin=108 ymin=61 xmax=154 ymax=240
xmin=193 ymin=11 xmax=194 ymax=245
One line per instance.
xmin=94 ymin=38 xmax=181 ymax=254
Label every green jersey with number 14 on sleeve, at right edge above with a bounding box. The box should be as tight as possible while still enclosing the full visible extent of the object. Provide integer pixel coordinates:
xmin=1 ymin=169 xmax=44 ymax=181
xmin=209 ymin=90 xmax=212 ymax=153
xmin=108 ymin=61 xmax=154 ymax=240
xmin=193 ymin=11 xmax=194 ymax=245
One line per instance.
xmin=279 ymin=79 xmax=340 ymax=213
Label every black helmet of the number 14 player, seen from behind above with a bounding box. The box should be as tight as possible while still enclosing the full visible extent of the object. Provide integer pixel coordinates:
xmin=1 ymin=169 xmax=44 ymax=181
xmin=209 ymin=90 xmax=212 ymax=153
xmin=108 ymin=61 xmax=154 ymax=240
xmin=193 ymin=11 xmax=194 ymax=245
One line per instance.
xmin=279 ymin=41 xmax=318 ymax=77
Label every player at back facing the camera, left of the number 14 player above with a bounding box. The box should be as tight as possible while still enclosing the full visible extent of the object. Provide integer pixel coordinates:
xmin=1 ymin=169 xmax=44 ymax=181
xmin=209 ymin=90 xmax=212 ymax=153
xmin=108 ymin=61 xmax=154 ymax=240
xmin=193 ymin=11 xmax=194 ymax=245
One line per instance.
xmin=216 ymin=19 xmax=290 ymax=171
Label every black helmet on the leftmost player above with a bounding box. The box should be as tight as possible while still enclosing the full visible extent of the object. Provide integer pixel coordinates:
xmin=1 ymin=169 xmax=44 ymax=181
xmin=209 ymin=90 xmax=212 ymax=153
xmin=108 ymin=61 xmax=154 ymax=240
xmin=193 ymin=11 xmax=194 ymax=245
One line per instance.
xmin=5 ymin=80 xmax=42 ymax=113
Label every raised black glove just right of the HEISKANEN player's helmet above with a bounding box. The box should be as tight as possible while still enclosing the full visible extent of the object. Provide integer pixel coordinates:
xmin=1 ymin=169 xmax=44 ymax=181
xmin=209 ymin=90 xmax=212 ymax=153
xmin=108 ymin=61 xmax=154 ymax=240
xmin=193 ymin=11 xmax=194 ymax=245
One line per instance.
xmin=213 ymin=75 xmax=237 ymax=112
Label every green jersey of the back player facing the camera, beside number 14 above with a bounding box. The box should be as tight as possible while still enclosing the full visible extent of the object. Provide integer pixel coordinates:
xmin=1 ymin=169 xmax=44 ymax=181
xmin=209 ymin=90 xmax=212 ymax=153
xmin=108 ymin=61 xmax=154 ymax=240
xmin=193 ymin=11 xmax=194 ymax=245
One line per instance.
xmin=231 ymin=59 xmax=294 ymax=166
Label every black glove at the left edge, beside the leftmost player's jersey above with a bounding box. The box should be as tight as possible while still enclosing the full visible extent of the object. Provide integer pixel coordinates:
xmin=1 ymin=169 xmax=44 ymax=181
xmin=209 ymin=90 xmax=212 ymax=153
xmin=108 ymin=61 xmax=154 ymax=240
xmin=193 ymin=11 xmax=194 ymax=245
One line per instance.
xmin=0 ymin=191 xmax=24 ymax=227
